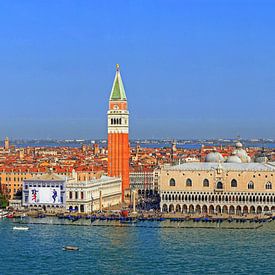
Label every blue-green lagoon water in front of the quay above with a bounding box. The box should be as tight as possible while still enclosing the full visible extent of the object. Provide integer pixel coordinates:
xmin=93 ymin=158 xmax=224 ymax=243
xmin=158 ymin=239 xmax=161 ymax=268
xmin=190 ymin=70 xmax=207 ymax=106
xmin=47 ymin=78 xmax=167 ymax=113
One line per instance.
xmin=0 ymin=220 xmax=275 ymax=275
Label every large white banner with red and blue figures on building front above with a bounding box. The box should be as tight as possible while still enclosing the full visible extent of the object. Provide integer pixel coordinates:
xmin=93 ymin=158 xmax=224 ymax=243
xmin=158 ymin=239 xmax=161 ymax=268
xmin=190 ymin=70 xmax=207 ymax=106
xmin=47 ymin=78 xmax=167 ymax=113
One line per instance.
xmin=29 ymin=187 xmax=61 ymax=204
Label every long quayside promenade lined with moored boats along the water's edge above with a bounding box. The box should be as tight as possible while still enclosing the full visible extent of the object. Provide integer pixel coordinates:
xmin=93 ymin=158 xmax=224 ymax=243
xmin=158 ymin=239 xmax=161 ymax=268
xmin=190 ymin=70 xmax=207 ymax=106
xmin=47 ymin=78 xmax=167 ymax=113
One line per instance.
xmin=7 ymin=210 xmax=275 ymax=229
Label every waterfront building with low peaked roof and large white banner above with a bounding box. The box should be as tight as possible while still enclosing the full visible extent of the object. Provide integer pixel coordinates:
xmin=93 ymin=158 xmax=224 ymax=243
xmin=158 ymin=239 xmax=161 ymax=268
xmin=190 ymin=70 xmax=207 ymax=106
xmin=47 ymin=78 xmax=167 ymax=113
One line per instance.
xmin=22 ymin=174 xmax=67 ymax=209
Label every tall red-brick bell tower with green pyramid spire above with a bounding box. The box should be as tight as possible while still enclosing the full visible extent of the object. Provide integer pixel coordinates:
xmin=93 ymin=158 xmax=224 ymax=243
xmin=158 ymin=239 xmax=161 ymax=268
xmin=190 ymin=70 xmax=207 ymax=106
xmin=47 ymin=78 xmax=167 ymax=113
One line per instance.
xmin=108 ymin=65 xmax=130 ymax=201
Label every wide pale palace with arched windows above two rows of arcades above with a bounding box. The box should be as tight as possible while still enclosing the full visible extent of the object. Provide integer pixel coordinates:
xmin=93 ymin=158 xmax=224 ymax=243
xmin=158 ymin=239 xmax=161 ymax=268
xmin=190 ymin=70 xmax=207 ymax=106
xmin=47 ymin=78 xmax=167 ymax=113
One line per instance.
xmin=160 ymin=162 xmax=275 ymax=215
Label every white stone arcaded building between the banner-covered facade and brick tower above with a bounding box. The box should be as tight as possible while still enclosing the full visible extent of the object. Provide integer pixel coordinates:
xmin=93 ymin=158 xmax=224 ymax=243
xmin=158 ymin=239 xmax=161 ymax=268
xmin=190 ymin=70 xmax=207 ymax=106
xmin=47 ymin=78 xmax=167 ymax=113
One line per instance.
xmin=66 ymin=176 xmax=121 ymax=213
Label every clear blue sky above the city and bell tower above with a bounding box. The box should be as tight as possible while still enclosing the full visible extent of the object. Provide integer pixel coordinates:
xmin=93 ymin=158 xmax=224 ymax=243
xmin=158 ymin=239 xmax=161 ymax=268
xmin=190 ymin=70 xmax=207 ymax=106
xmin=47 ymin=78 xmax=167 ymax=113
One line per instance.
xmin=0 ymin=0 xmax=275 ymax=139
